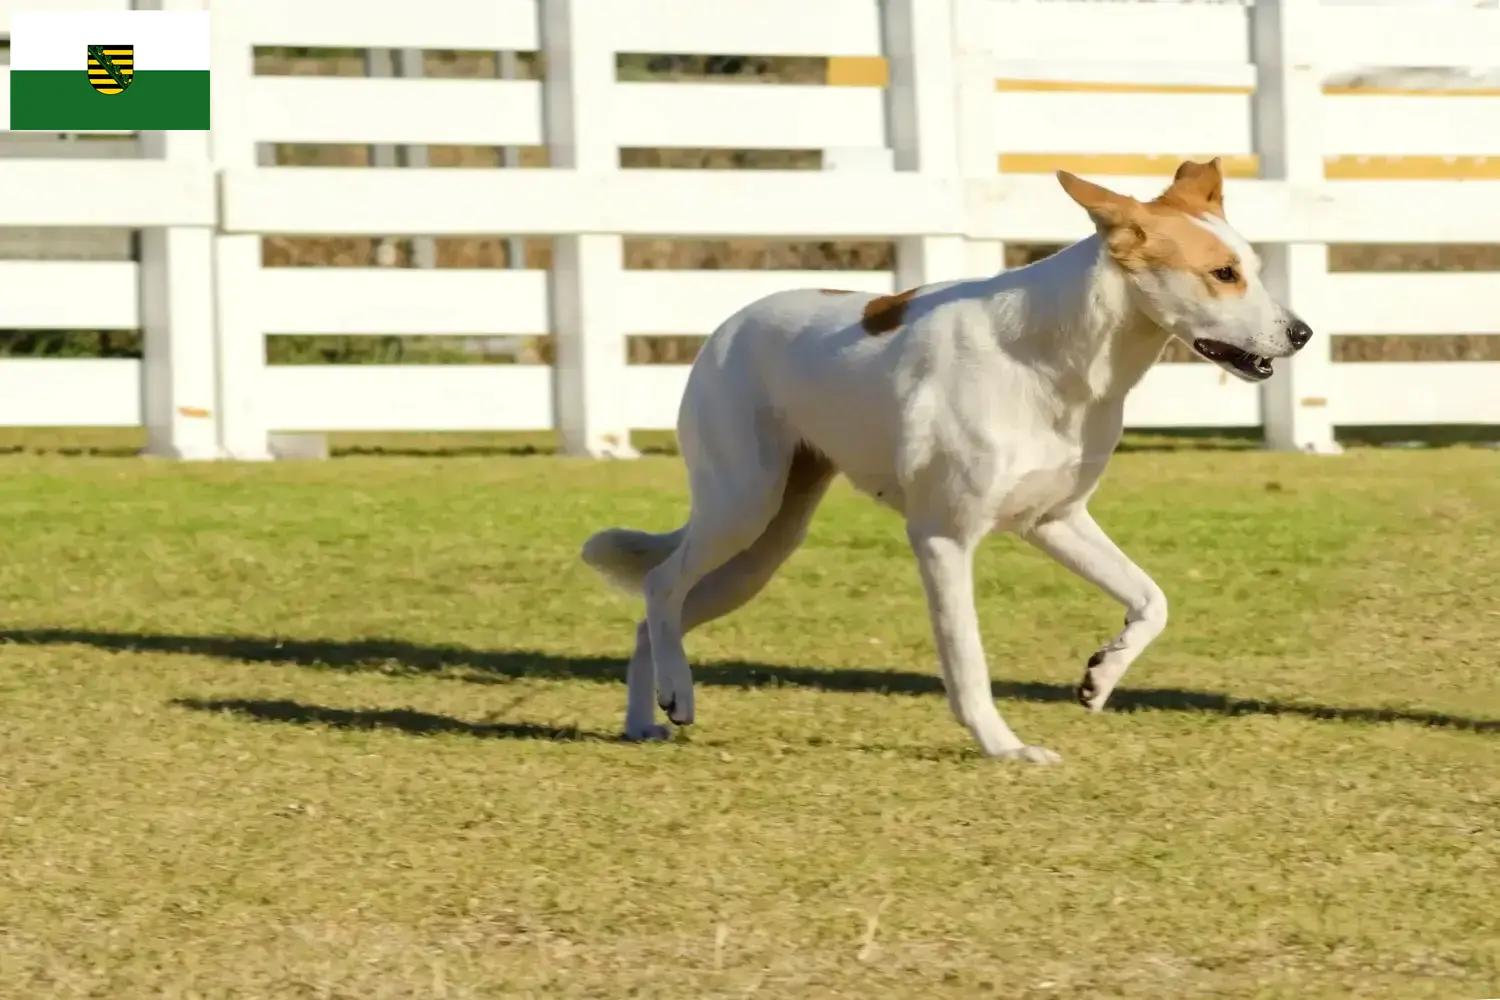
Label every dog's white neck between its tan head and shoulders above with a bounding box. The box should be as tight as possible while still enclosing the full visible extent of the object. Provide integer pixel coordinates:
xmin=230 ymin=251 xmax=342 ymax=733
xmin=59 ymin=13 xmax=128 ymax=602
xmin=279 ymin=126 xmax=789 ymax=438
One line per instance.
xmin=990 ymin=234 xmax=1170 ymax=402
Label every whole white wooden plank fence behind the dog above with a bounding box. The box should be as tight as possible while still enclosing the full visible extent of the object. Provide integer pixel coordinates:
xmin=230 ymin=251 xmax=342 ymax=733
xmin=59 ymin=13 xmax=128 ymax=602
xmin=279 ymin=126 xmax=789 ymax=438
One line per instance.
xmin=0 ymin=0 xmax=1500 ymax=459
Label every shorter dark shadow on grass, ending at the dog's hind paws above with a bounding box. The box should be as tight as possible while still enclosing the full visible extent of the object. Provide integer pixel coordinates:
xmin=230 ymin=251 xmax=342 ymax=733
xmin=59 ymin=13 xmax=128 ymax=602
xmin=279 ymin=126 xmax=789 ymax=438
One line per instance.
xmin=170 ymin=699 xmax=617 ymax=742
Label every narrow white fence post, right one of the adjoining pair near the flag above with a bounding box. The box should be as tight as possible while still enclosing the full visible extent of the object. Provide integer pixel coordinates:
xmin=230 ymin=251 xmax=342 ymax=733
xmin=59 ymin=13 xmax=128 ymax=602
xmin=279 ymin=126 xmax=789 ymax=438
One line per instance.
xmin=210 ymin=0 xmax=272 ymax=462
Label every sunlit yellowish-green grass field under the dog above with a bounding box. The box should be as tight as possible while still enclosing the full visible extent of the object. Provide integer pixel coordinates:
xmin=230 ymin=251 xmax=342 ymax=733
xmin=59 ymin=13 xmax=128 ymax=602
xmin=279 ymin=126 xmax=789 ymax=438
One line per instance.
xmin=0 ymin=447 xmax=1500 ymax=1000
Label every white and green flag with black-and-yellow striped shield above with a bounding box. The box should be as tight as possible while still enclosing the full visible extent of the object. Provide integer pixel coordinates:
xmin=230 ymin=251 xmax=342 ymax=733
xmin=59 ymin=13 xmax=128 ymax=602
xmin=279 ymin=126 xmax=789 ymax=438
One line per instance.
xmin=11 ymin=10 xmax=211 ymax=132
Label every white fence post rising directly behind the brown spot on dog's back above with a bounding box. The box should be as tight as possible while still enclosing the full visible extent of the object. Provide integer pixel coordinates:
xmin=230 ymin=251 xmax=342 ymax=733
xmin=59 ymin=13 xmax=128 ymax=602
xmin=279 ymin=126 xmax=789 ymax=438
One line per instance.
xmin=881 ymin=0 xmax=969 ymax=289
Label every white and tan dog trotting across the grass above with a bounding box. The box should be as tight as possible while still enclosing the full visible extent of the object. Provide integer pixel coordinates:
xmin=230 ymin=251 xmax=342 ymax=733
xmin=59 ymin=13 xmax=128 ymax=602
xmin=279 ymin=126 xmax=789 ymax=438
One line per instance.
xmin=582 ymin=159 xmax=1313 ymax=763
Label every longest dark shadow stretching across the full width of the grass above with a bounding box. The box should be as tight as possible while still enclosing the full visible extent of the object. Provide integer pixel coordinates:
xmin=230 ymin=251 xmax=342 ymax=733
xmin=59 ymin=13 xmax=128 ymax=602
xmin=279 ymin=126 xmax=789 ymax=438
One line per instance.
xmin=0 ymin=628 xmax=1500 ymax=735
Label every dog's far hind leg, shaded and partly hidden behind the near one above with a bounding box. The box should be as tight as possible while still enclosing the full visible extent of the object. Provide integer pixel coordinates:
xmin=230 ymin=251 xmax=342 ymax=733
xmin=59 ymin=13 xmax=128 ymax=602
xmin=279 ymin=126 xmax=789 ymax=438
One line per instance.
xmin=626 ymin=447 xmax=834 ymax=739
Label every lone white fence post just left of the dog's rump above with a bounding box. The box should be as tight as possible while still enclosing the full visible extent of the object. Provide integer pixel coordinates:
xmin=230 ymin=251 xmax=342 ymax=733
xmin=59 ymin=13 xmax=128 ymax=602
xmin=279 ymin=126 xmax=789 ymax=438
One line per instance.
xmin=540 ymin=0 xmax=638 ymax=459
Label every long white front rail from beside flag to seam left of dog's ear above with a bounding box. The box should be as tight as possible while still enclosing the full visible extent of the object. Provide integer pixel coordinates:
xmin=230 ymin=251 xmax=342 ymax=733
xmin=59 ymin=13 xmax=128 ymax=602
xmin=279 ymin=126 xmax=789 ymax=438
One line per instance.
xmin=222 ymin=168 xmax=966 ymax=237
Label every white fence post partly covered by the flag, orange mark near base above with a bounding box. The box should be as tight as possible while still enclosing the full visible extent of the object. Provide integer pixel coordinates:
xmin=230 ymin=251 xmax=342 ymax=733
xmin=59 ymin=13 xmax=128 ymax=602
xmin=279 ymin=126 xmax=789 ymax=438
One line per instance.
xmin=134 ymin=0 xmax=219 ymax=460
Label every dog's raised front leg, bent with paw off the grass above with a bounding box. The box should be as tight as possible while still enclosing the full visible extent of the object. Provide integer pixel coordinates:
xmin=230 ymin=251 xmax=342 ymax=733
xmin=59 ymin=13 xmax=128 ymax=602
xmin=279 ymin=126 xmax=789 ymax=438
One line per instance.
xmin=1026 ymin=507 xmax=1167 ymax=712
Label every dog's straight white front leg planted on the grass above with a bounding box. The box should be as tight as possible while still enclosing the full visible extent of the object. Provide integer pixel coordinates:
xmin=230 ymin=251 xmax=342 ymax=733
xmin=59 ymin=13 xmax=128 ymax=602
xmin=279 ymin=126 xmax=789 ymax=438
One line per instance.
xmin=906 ymin=526 xmax=1061 ymax=763
